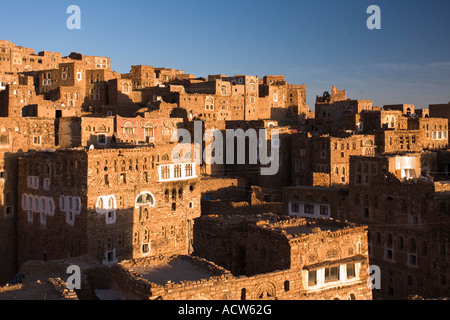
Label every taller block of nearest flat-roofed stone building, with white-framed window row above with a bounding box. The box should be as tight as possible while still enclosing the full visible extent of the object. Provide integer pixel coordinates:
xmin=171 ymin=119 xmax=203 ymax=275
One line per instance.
xmin=169 ymin=215 xmax=372 ymax=300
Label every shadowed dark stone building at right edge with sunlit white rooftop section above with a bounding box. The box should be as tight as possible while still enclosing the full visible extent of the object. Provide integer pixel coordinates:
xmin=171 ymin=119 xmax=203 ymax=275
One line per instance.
xmin=346 ymin=154 xmax=450 ymax=299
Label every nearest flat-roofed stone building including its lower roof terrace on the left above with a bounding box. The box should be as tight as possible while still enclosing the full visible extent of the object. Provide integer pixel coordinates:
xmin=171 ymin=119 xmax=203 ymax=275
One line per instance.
xmin=107 ymin=214 xmax=372 ymax=301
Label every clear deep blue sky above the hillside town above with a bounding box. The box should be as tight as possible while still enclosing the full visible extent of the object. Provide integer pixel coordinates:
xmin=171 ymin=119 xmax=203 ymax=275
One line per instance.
xmin=0 ymin=0 xmax=450 ymax=108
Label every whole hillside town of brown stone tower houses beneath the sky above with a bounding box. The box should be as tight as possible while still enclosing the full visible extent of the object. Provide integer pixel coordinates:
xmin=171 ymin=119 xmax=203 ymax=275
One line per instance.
xmin=0 ymin=40 xmax=450 ymax=300
